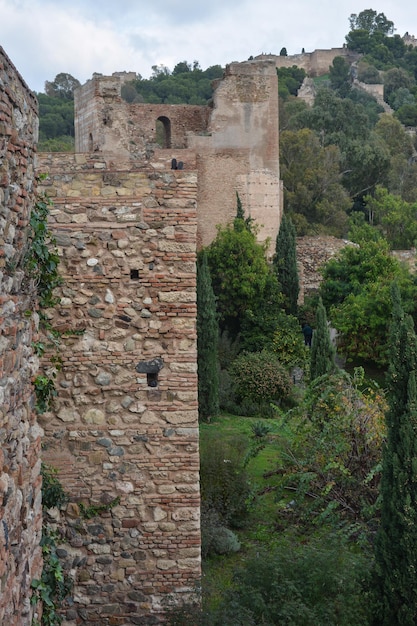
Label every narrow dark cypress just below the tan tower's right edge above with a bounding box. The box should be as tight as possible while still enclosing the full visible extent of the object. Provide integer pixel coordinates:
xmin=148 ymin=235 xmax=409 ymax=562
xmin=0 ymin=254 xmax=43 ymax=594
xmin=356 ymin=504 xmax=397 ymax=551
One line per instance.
xmin=273 ymin=214 xmax=300 ymax=315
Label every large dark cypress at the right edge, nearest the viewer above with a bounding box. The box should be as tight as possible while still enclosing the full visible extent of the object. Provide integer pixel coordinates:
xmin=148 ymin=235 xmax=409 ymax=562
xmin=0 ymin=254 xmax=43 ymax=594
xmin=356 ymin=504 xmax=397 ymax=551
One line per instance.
xmin=374 ymin=285 xmax=417 ymax=626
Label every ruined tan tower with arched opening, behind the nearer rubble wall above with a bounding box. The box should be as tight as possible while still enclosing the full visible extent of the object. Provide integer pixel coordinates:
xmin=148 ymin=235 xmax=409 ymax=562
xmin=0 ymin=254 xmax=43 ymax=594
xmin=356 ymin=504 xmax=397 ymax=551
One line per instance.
xmin=75 ymin=60 xmax=282 ymax=254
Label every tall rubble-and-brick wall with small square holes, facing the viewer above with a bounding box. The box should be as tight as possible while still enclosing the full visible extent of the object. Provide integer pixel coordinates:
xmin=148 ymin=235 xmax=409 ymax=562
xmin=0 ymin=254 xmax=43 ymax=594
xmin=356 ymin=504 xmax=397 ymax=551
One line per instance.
xmin=39 ymin=153 xmax=201 ymax=625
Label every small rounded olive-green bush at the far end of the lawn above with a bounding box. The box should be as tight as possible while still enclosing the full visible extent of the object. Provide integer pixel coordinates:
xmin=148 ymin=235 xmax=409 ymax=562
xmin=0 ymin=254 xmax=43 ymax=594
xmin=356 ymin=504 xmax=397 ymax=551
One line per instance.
xmin=229 ymin=351 xmax=292 ymax=404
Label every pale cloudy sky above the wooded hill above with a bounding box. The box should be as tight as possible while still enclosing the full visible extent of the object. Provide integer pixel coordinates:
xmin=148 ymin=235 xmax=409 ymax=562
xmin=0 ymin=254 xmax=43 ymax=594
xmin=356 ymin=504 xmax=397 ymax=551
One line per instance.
xmin=0 ymin=0 xmax=417 ymax=91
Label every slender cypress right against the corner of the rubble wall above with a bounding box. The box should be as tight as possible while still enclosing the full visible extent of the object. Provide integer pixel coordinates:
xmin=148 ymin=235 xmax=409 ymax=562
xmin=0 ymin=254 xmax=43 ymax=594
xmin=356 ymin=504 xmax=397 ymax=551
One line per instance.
xmin=197 ymin=251 xmax=219 ymax=420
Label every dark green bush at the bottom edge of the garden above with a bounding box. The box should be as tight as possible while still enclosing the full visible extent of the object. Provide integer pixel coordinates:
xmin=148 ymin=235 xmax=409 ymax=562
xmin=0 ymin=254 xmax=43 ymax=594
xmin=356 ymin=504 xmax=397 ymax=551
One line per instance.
xmin=214 ymin=537 xmax=369 ymax=626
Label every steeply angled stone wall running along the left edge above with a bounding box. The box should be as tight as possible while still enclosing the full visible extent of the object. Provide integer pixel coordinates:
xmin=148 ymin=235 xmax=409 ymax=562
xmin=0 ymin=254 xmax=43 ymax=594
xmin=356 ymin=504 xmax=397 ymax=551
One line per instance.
xmin=0 ymin=48 xmax=42 ymax=626
